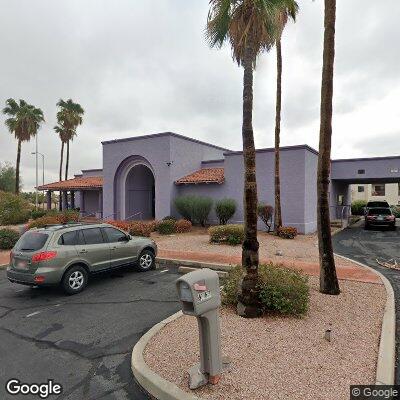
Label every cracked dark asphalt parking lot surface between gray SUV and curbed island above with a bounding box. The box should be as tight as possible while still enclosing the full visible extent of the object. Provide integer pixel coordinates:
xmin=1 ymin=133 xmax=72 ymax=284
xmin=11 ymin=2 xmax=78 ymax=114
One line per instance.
xmin=0 ymin=268 xmax=179 ymax=400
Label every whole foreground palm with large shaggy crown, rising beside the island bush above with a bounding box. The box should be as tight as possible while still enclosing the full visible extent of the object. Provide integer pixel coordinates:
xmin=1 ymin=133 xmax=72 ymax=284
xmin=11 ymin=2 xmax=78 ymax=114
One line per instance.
xmin=206 ymin=0 xmax=282 ymax=317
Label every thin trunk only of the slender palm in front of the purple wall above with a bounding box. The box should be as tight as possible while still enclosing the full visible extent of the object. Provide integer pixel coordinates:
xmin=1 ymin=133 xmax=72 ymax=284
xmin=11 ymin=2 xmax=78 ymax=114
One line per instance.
xmin=274 ymin=39 xmax=282 ymax=233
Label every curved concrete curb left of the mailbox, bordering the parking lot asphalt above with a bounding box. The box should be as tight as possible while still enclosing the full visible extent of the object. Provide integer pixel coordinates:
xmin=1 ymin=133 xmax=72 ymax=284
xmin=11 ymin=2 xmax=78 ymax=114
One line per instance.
xmin=131 ymin=311 xmax=201 ymax=400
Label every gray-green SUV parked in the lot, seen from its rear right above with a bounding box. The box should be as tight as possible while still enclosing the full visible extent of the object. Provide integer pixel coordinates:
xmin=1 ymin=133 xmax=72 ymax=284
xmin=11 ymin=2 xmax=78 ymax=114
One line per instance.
xmin=7 ymin=223 xmax=157 ymax=294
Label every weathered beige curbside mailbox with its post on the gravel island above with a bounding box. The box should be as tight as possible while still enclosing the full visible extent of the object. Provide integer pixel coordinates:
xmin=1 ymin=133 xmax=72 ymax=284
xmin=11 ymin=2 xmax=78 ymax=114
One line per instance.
xmin=176 ymin=268 xmax=222 ymax=389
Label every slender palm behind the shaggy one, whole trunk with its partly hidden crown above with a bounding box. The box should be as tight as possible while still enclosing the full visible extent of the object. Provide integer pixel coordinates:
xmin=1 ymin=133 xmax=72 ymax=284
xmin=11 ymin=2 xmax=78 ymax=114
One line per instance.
xmin=274 ymin=0 xmax=299 ymax=233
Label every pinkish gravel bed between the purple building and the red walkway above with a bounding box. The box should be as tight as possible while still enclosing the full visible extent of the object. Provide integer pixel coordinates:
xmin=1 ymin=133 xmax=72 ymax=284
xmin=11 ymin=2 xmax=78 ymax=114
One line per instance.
xmin=152 ymin=227 xmax=353 ymax=265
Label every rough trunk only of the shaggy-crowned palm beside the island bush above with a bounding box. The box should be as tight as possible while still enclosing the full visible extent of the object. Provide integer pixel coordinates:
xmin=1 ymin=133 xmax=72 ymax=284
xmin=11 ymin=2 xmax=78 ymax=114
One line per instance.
xmin=238 ymin=45 xmax=261 ymax=318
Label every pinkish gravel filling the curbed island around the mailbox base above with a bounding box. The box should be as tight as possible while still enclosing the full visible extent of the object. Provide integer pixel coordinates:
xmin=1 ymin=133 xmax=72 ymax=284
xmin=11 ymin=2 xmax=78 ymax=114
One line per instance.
xmin=145 ymin=278 xmax=386 ymax=400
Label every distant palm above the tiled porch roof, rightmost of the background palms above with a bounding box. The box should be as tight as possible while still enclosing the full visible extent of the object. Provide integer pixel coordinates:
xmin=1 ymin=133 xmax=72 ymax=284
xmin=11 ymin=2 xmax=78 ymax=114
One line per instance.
xmin=57 ymin=99 xmax=85 ymax=180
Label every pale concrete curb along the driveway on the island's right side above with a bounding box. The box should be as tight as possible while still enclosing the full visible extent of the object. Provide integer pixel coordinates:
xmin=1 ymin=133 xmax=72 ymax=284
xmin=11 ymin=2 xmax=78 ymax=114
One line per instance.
xmin=335 ymin=253 xmax=396 ymax=385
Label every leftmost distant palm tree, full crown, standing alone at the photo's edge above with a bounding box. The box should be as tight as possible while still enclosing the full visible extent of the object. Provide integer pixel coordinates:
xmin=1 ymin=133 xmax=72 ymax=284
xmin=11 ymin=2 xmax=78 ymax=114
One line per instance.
xmin=3 ymin=99 xmax=44 ymax=194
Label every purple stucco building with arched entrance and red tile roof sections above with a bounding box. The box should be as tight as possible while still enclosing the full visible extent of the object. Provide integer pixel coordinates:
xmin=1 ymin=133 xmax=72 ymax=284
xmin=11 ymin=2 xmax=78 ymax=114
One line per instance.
xmin=41 ymin=132 xmax=400 ymax=233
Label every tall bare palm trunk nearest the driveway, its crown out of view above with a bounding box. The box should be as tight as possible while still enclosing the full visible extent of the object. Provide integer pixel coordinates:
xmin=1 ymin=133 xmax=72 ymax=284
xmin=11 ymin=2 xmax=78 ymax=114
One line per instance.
xmin=317 ymin=0 xmax=340 ymax=295
